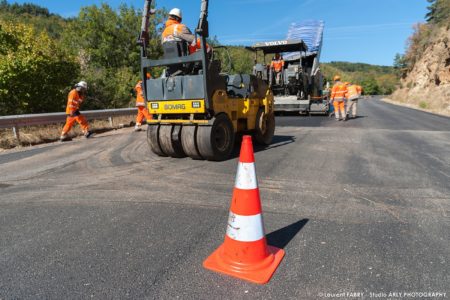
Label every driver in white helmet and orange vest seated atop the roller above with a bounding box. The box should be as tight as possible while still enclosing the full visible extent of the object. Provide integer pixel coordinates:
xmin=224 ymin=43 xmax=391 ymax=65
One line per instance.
xmin=162 ymin=8 xmax=195 ymax=44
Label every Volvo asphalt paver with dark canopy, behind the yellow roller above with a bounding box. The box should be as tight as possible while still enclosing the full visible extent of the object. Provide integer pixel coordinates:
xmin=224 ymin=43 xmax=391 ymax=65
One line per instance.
xmin=247 ymin=22 xmax=329 ymax=114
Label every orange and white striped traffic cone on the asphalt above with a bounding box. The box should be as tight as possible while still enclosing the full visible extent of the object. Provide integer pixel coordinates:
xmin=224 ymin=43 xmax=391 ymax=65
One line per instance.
xmin=203 ymin=136 xmax=284 ymax=284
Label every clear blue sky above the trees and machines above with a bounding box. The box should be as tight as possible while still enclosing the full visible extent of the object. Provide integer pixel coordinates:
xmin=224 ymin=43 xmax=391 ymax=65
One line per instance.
xmin=10 ymin=0 xmax=427 ymax=65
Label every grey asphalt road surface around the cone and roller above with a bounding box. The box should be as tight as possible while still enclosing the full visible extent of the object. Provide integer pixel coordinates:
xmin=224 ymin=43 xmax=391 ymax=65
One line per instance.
xmin=0 ymin=98 xmax=450 ymax=299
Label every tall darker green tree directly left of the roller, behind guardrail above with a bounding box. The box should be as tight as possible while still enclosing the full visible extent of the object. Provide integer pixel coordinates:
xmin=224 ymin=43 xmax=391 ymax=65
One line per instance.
xmin=60 ymin=3 xmax=163 ymax=108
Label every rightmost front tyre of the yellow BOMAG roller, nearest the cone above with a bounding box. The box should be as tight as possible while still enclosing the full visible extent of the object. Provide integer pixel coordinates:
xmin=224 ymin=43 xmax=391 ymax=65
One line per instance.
xmin=197 ymin=114 xmax=235 ymax=161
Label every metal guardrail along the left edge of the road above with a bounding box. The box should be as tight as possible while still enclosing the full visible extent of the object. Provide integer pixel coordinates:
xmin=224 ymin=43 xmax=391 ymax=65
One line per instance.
xmin=0 ymin=108 xmax=136 ymax=139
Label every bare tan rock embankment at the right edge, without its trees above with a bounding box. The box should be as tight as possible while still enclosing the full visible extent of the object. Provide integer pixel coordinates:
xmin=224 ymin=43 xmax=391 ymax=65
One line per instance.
xmin=389 ymin=27 xmax=450 ymax=115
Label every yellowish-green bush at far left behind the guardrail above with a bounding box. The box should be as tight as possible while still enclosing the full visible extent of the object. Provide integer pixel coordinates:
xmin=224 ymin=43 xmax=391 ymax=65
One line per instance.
xmin=0 ymin=21 xmax=78 ymax=115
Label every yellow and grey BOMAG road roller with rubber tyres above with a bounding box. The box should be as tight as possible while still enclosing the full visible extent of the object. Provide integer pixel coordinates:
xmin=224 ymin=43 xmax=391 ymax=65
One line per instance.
xmin=138 ymin=0 xmax=275 ymax=161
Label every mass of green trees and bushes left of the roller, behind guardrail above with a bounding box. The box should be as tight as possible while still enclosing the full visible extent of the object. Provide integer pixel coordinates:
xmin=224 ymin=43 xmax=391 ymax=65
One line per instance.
xmin=0 ymin=0 xmax=166 ymax=114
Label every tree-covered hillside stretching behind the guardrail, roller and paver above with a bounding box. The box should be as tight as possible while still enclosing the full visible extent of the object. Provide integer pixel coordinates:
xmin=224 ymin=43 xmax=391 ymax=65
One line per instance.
xmin=0 ymin=0 xmax=397 ymax=115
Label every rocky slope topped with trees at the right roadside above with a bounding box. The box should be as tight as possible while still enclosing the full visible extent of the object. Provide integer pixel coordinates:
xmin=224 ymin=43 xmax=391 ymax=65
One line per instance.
xmin=392 ymin=0 xmax=450 ymax=115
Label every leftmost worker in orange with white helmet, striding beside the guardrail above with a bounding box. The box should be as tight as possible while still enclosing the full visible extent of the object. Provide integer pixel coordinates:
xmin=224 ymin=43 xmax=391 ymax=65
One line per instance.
xmin=60 ymin=81 xmax=92 ymax=142
